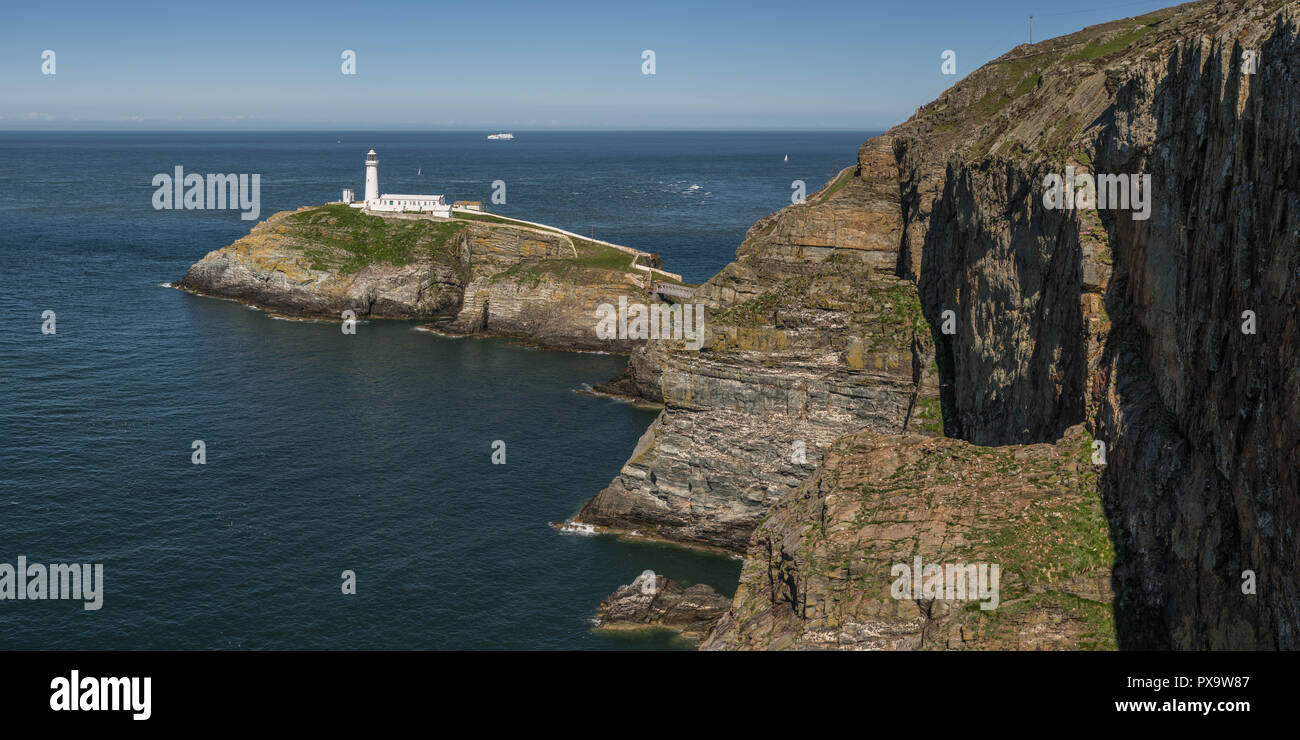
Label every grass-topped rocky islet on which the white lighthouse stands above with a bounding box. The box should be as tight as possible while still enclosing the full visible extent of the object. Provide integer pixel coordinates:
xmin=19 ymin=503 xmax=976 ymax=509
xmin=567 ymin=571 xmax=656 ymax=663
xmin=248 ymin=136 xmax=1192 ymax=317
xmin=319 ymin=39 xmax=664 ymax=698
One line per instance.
xmin=178 ymin=205 xmax=660 ymax=351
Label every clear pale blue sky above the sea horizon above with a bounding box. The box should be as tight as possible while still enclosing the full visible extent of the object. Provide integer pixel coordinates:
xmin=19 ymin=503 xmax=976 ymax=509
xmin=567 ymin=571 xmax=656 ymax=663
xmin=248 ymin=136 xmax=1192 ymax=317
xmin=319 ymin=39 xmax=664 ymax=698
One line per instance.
xmin=0 ymin=0 xmax=1171 ymax=131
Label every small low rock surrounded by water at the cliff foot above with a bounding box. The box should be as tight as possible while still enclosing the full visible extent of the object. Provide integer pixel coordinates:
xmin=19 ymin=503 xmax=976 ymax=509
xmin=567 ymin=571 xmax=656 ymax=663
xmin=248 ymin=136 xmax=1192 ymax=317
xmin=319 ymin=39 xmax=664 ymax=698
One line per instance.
xmin=597 ymin=571 xmax=731 ymax=641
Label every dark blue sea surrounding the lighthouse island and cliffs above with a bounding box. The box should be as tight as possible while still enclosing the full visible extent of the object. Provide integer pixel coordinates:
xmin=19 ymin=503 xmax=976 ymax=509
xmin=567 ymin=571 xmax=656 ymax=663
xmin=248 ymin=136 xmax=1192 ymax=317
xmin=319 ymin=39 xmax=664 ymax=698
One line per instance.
xmin=0 ymin=131 xmax=871 ymax=650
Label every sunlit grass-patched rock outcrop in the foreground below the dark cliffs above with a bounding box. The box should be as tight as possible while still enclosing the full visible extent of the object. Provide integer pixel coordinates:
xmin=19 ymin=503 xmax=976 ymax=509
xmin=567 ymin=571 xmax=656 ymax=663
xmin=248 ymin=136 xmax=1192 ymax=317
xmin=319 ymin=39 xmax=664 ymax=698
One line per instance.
xmin=703 ymin=427 xmax=1115 ymax=650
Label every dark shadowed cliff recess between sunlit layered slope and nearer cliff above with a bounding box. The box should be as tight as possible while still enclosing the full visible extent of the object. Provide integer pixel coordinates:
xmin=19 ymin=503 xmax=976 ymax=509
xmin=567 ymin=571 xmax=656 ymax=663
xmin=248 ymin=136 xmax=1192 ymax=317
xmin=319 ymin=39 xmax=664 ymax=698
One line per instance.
xmin=900 ymin=157 xmax=1088 ymax=446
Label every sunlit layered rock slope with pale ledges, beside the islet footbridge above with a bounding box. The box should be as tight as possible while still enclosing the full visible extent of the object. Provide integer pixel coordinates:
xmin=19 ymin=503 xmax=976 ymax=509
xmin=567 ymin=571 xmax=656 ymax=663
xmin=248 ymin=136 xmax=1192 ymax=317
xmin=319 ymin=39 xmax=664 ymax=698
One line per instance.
xmin=577 ymin=139 xmax=940 ymax=551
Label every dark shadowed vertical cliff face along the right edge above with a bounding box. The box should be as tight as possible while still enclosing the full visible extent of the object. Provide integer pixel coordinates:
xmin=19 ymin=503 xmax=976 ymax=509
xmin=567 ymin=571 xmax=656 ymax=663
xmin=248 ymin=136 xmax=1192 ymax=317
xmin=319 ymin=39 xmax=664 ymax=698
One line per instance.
xmin=1097 ymin=18 xmax=1300 ymax=649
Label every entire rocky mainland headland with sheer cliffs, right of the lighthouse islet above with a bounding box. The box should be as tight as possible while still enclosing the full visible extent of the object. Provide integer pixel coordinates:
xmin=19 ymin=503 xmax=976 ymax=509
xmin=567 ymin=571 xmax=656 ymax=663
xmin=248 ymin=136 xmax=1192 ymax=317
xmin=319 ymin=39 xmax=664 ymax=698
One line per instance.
xmin=579 ymin=1 xmax=1300 ymax=649
